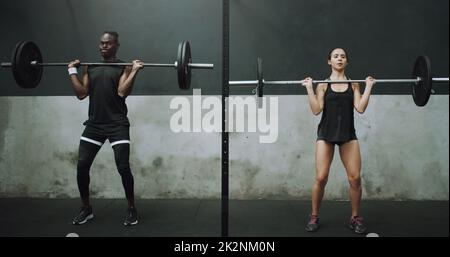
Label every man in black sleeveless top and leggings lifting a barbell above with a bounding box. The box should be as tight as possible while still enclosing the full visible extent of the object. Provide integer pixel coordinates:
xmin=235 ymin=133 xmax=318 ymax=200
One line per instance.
xmin=68 ymin=31 xmax=143 ymax=226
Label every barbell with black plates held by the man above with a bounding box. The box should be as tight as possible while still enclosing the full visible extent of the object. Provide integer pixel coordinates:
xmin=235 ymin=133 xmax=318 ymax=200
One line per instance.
xmin=0 ymin=41 xmax=214 ymax=89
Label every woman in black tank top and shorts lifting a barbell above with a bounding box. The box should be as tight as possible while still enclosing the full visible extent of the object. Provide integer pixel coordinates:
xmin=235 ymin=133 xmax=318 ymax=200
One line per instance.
xmin=303 ymin=48 xmax=375 ymax=234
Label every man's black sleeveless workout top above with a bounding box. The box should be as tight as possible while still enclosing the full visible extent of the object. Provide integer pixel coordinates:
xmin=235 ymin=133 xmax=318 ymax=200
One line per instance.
xmin=84 ymin=60 xmax=130 ymax=126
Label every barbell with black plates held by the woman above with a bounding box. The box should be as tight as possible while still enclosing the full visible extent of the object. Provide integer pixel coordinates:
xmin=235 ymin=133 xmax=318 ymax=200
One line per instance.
xmin=229 ymin=55 xmax=449 ymax=106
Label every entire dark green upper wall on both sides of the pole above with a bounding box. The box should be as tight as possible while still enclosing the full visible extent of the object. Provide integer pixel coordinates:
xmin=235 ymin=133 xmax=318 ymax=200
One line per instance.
xmin=0 ymin=0 xmax=449 ymax=96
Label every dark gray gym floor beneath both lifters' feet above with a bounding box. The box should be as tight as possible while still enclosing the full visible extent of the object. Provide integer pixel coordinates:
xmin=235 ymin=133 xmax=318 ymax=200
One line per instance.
xmin=0 ymin=198 xmax=449 ymax=237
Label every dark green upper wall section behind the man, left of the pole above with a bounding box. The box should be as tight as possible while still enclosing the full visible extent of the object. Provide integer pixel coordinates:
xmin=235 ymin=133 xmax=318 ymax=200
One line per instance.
xmin=0 ymin=0 xmax=222 ymax=95
